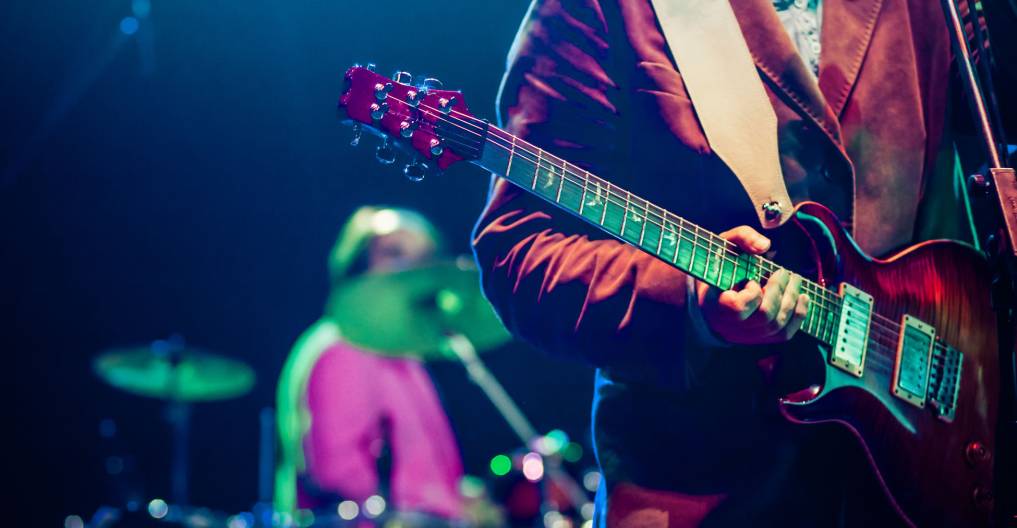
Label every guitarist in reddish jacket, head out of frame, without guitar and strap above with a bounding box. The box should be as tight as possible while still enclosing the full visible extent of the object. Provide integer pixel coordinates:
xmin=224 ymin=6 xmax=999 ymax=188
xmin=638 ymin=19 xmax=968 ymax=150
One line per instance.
xmin=474 ymin=0 xmax=1012 ymax=528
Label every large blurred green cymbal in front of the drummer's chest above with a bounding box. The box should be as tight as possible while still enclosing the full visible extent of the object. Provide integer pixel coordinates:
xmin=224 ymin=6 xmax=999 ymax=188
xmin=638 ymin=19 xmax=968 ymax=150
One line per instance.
xmin=326 ymin=257 xmax=510 ymax=361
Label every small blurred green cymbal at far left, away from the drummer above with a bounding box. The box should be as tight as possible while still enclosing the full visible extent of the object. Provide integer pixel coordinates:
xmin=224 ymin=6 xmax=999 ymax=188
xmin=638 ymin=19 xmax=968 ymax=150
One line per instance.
xmin=93 ymin=341 xmax=254 ymax=402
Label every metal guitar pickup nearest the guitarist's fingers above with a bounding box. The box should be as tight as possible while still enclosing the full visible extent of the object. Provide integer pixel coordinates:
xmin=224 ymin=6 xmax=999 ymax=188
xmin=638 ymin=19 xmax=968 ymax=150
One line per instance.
xmin=830 ymin=283 xmax=873 ymax=377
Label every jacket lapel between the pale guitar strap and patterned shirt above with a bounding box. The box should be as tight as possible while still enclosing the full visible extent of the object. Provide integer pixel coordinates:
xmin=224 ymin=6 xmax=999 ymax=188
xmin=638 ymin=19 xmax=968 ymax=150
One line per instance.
xmin=731 ymin=0 xmax=856 ymax=146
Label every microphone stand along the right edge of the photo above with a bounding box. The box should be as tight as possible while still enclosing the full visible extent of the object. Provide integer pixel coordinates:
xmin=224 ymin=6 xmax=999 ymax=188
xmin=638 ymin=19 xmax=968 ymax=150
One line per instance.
xmin=942 ymin=0 xmax=1017 ymax=526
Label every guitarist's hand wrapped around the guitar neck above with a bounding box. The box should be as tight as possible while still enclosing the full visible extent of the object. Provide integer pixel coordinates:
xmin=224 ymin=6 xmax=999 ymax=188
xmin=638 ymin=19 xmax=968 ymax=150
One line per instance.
xmin=696 ymin=226 xmax=809 ymax=345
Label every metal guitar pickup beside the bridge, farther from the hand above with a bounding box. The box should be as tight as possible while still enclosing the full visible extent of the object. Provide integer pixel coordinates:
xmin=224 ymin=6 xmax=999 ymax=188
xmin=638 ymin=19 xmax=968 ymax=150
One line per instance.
xmin=891 ymin=314 xmax=936 ymax=408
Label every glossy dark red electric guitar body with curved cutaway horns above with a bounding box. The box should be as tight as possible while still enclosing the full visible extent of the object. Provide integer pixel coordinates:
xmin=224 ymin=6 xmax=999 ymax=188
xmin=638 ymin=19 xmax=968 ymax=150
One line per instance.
xmin=781 ymin=203 xmax=999 ymax=527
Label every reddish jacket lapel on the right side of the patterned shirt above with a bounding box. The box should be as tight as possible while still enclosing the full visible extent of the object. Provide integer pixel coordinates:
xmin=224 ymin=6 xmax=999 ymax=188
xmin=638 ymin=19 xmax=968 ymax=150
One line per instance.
xmin=820 ymin=0 xmax=883 ymax=116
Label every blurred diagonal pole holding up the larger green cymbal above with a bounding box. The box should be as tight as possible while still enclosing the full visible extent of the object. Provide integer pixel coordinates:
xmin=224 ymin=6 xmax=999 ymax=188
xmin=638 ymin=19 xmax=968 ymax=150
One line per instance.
xmin=445 ymin=334 xmax=590 ymax=509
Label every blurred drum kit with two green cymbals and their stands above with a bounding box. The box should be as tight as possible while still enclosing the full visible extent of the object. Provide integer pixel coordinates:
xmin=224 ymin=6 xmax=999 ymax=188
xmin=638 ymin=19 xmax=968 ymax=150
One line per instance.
xmin=91 ymin=257 xmax=592 ymax=528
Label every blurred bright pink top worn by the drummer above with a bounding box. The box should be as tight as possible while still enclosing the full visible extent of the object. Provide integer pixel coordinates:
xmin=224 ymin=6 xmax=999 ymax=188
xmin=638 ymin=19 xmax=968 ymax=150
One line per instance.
xmin=299 ymin=342 xmax=463 ymax=519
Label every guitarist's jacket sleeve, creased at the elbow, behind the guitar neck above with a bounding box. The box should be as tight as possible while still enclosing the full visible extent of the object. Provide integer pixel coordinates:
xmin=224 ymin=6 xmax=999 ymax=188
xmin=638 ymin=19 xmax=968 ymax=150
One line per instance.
xmin=473 ymin=0 xmax=707 ymax=386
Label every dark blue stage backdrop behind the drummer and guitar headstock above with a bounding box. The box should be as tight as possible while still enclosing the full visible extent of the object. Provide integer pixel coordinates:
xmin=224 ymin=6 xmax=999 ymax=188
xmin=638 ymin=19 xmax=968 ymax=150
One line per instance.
xmin=0 ymin=0 xmax=592 ymax=526
